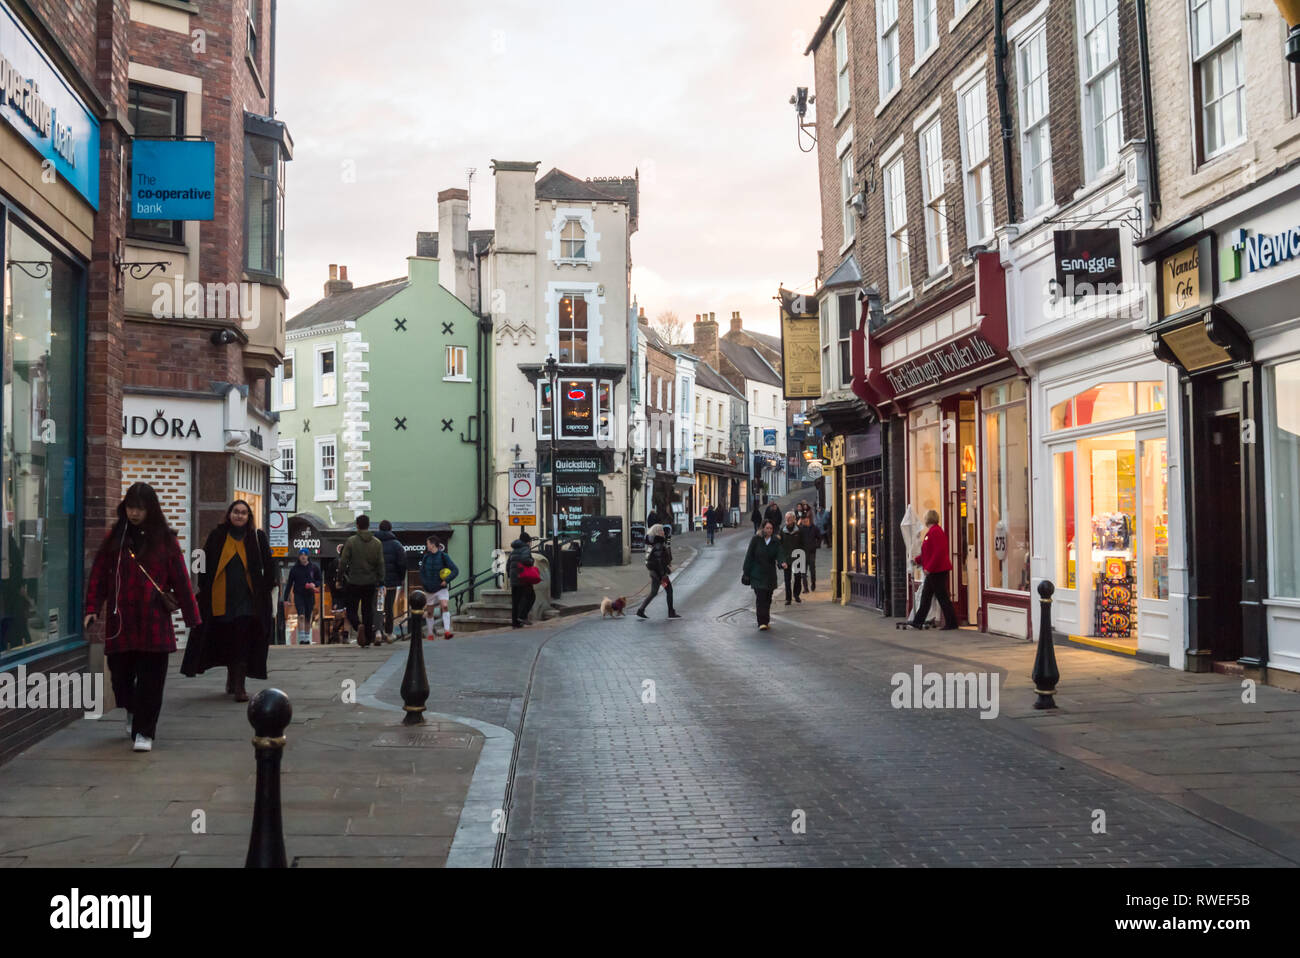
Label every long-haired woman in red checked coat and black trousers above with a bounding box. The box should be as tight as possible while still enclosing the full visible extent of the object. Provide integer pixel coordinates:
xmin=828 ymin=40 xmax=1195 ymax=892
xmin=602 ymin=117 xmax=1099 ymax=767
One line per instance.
xmin=85 ymin=482 xmax=199 ymax=751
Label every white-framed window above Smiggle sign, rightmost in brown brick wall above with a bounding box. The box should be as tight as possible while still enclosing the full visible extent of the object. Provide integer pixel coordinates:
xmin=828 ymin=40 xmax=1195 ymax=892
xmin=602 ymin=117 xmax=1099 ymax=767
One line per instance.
xmin=1079 ymin=0 xmax=1123 ymax=179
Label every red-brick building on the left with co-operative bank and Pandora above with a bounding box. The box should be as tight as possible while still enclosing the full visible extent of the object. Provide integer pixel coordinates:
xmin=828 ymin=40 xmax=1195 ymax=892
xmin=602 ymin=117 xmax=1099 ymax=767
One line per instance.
xmin=0 ymin=0 xmax=291 ymax=760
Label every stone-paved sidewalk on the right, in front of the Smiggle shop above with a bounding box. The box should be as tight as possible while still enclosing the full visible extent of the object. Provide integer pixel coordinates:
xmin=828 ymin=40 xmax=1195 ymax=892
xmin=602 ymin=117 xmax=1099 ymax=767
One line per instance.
xmin=772 ymin=589 xmax=1300 ymax=863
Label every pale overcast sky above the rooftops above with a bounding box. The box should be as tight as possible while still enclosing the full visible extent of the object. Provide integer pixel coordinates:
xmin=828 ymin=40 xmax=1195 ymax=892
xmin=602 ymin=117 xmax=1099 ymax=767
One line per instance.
xmin=276 ymin=0 xmax=829 ymax=339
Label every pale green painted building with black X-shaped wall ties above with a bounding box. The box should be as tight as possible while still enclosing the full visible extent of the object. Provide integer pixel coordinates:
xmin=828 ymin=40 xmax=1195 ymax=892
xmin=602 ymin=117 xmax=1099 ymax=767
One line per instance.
xmin=272 ymin=215 xmax=491 ymax=586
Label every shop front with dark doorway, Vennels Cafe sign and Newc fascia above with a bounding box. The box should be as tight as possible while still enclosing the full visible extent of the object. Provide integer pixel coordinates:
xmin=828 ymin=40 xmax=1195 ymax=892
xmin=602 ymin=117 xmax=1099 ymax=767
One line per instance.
xmin=1144 ymin=170 xmax=1300 ymax=688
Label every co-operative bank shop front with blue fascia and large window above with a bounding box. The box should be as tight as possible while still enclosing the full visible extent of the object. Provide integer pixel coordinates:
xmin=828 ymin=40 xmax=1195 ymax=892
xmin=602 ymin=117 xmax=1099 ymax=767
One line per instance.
xmin=0 ymin=3 xmax=104 ymax=760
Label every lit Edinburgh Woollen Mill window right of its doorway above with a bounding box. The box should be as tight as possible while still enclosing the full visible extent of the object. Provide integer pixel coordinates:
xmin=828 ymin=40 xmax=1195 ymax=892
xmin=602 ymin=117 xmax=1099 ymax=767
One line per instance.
xmin=983 ymin=381 xmax=1030 ymax=591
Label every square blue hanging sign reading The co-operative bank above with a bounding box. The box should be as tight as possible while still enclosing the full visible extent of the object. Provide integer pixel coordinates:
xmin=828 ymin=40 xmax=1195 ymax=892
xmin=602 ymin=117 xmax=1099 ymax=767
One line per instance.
xmin=131 ymin=139 xmax=217 ymax=220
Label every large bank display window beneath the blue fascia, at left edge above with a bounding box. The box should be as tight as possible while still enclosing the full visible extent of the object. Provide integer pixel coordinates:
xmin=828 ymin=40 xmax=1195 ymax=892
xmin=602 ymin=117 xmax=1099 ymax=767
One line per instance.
xmin=0 ymin=214 xmax=81 ymax=655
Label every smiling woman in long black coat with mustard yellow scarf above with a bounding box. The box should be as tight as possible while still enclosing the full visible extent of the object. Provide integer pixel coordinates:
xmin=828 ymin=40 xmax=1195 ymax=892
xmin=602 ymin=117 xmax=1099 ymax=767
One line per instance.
xmin=181 ymin=499 xmax=277 ymax=702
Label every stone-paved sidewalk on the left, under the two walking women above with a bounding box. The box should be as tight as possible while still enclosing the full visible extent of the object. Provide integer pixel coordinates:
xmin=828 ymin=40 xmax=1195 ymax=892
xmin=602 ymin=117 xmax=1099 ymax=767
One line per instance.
xmin=0 ymin=645 xmax=484 ymax=867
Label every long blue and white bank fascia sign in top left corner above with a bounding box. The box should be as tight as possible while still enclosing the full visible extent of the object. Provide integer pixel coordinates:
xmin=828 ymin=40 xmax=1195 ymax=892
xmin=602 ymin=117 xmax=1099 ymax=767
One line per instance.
xmin=0 ymin=3 xmax=99 ymax=209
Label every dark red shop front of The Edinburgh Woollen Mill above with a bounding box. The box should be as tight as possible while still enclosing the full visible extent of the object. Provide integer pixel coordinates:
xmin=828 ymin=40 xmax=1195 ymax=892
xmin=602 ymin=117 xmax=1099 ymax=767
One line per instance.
xmin=853 ymin=252 xmax=1032 ymax=638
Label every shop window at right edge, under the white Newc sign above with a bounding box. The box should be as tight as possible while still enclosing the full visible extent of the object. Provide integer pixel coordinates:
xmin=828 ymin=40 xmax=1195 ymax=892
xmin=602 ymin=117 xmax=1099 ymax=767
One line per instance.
xmin=1265 ymin=360 xmax=1300 ymax=599
